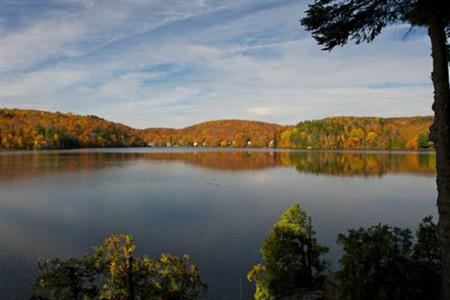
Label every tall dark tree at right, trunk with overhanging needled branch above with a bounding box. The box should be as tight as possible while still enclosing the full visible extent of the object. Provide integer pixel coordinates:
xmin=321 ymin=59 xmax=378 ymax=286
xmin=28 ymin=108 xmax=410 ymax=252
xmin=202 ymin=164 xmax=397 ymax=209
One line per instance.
xmin=301 ymin=0 xmax=450 ymax=299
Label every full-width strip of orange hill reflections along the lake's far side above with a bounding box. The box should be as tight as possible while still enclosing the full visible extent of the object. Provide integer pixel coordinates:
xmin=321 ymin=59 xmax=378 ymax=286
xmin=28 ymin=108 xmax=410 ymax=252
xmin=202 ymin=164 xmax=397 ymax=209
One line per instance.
xmin=0 ymin=151 xmax=436 ymax=180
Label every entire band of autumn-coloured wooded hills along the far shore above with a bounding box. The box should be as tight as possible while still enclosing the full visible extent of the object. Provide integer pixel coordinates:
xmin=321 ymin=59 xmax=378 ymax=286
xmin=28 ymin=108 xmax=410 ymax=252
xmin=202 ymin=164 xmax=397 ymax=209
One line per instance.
xmin=0 ymin=109 xmax=432 ymax=150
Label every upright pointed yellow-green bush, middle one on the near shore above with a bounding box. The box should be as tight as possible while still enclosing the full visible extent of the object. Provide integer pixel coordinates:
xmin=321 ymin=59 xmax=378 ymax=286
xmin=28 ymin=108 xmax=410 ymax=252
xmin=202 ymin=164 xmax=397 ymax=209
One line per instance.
xmin=247 ymin=204 xmax=328 ymax=300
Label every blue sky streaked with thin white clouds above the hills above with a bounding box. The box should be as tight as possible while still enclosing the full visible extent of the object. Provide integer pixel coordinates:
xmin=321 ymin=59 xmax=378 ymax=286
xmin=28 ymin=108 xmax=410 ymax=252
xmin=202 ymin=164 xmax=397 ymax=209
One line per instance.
xmin=0 ymin=0 xmax=433 ymax=128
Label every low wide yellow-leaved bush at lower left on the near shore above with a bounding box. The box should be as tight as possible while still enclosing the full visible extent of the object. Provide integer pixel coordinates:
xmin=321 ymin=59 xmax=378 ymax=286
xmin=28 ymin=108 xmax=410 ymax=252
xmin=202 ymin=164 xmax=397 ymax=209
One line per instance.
xmin=32 ymin=234 xmax=206 ymax=300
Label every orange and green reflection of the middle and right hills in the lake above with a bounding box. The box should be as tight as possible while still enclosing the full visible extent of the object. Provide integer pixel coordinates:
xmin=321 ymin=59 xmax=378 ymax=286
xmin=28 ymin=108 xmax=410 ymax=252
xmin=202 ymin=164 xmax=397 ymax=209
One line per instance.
xmin=148 ymin=151 xmax=436 ymax=176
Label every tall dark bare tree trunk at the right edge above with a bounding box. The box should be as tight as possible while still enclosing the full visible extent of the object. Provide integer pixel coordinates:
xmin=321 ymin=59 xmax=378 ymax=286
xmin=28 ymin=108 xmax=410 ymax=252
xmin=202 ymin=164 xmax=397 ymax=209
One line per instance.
xmin=428 ymin=18 xmax=450 ymax=300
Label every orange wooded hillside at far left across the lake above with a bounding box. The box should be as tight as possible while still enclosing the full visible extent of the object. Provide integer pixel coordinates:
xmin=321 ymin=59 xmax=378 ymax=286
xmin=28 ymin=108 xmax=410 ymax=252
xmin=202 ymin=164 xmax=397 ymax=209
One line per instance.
xmin=0 ymin=109 xmax=145 ymax=149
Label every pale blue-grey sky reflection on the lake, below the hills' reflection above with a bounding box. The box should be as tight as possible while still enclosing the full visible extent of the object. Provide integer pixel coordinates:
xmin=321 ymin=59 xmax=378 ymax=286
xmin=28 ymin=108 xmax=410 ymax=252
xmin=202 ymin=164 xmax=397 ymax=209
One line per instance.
xmin=0 ymin=154 xmax=436 ymax=299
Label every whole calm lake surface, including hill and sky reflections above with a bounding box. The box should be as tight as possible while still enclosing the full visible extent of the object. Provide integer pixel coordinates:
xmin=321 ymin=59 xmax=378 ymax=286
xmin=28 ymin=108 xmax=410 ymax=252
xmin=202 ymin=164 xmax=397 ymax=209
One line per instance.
xmin=0 ymin=148 xmax=436 ymax=299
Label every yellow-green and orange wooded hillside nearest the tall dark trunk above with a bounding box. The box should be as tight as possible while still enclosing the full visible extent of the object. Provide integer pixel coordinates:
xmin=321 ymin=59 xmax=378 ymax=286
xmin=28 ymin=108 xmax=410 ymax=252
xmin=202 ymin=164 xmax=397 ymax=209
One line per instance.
xmin=276 ymin=117 xmax=433 ymax=150
